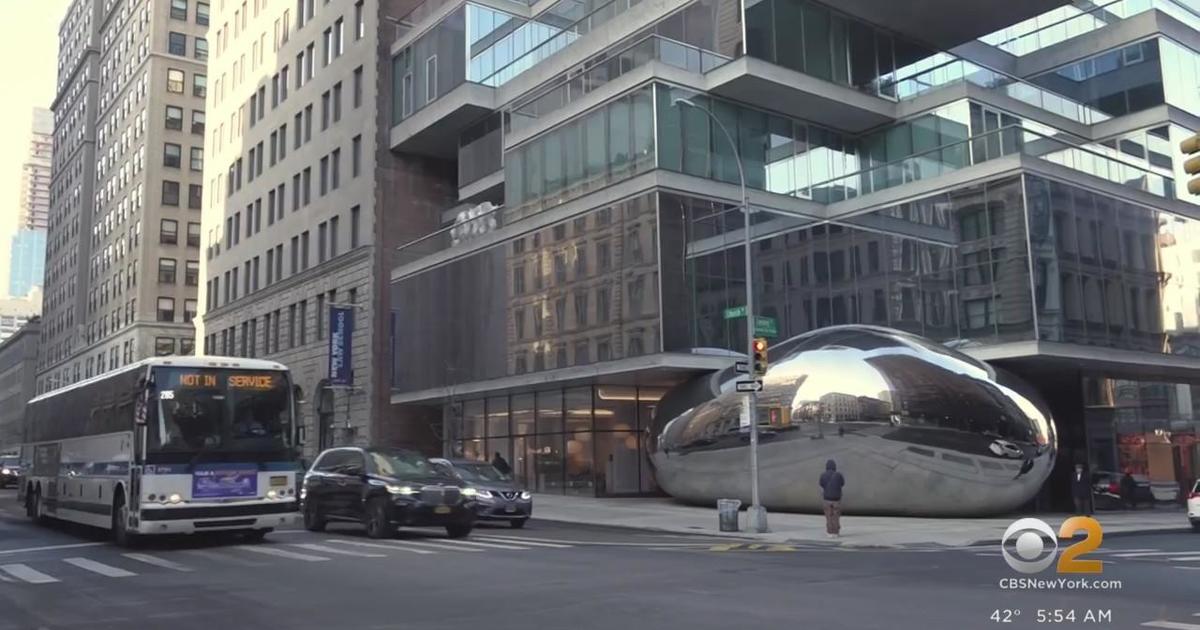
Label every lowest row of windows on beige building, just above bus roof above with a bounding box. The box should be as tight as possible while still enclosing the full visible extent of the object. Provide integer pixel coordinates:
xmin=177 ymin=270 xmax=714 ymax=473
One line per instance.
xmin=204 ymin=288 xmax=359 ymax=358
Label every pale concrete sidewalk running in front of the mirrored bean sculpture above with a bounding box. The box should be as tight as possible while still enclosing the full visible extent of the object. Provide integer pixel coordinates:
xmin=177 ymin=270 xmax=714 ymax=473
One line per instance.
xmin=534 ymin=494 xmax=1185 ymax=547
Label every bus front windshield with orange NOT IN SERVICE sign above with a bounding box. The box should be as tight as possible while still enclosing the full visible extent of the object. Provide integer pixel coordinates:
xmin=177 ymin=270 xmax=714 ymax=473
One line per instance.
xmin=146 ymin=367 xmax=290 ymax=452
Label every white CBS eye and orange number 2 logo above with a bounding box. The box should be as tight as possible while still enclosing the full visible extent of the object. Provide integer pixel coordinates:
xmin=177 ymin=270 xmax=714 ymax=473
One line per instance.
xmin=1000 ymin=516 xmax=1104 ymax=574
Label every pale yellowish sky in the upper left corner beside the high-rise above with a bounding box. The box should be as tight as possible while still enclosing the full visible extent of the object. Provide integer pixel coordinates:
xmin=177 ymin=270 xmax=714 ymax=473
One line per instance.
xmin=0 ymin=0 xmax=71 ymax=293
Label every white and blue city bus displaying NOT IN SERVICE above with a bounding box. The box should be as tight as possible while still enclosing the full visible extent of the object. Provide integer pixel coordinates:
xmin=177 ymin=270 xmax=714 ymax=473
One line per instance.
xmin=18 ymin=356 xmax=301 ymax=546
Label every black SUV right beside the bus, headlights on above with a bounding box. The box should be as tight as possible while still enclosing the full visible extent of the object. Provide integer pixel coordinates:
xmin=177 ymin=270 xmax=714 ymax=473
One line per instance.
xmin=300 ymin=448 xmax=476 ymax=538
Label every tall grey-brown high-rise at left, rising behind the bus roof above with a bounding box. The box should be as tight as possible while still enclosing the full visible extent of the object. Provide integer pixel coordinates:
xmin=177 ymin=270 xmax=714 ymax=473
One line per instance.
xmin=37 ymin=0 xmax=209 ymax=391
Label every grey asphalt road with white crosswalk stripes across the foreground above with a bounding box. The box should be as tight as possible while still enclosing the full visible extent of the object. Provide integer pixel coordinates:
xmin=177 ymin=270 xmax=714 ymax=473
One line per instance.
xmin=0 ymin=491 xmax=1200 ymax=630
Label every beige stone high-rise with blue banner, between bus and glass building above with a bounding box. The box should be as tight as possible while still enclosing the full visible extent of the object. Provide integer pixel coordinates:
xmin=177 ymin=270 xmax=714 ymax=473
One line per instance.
xmin=197 ymin=0 xmax=450 ymax=455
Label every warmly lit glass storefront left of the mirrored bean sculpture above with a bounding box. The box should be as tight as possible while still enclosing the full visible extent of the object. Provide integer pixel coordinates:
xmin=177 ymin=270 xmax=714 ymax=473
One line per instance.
xmin=445 ymin=385 xmax=666 ymax=497
